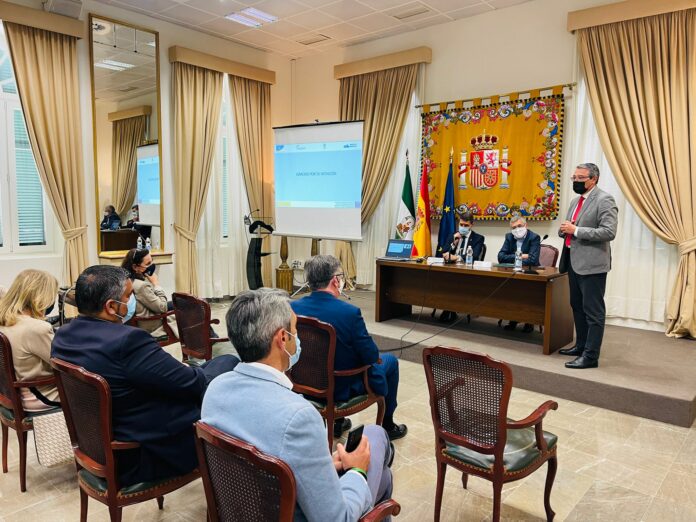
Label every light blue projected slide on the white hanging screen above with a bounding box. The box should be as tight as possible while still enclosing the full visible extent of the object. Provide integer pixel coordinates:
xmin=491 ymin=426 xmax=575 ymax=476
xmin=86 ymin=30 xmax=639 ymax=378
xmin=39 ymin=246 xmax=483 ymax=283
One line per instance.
xmin=275 ymin=141 xmax=362 ymax=208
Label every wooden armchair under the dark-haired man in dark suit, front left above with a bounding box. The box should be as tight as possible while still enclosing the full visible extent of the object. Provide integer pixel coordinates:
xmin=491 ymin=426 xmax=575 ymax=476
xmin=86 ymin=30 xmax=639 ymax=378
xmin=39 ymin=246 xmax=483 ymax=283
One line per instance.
xmin=51 ymin=358 xmax=200 ymax=522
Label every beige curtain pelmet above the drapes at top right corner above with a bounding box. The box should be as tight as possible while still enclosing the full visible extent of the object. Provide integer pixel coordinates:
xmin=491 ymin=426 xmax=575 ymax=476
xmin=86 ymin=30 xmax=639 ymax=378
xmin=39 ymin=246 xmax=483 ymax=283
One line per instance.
xmin=568 ymin=0 xmax=696 ymax=33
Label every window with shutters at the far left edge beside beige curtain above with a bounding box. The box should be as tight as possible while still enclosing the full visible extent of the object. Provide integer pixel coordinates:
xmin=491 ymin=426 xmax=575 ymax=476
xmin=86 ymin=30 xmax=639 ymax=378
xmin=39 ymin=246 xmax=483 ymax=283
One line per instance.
xmin=0 ymin=25 xmax=53 ymax=253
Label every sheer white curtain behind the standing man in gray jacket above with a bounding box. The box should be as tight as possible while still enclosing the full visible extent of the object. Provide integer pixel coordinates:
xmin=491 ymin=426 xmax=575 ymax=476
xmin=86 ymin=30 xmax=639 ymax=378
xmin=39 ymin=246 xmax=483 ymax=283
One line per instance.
xmin=562 ymin=78 xmax=679 ymax=331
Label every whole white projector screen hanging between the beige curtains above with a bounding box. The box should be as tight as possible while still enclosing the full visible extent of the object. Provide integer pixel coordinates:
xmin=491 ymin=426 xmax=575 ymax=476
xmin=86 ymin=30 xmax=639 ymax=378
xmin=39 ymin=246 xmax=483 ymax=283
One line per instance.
xmin=273 ymin=121 xmax=363 ymax=241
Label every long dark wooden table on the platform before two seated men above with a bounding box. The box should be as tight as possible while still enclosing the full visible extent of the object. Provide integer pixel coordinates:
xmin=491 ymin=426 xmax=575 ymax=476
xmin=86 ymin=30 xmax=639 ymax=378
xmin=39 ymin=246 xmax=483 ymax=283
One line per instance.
xmin=375 ymin=260 xmax=574 ymax=355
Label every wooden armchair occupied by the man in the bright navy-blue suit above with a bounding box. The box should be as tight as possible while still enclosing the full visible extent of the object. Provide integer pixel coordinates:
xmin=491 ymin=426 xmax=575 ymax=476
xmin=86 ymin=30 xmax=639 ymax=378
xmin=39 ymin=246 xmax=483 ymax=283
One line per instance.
xmin=288 ymin=315 xmax=385 ymax=450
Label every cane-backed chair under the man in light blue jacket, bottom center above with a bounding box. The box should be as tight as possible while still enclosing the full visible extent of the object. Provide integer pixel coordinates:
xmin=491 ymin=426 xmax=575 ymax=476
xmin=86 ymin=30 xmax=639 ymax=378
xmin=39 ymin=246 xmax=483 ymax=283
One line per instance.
xmin=195 ymin=420 xmax=401 ymax=522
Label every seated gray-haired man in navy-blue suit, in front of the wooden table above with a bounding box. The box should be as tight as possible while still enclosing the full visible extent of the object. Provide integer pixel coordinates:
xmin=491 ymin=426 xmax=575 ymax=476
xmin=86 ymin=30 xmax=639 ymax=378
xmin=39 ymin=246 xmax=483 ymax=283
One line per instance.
xmin=291 ymin=255 xmax=408 ymax=440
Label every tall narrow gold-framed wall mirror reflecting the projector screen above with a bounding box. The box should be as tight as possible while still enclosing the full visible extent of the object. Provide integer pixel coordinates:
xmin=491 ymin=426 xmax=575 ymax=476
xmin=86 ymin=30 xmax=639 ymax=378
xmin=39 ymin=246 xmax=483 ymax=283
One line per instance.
xmin=89 ymin=14 xmax=164 ymax=254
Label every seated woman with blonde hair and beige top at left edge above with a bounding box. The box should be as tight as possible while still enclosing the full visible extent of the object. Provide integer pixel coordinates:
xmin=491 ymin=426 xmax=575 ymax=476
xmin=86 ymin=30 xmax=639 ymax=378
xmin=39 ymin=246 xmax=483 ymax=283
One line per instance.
xmin=0 ymin=270 xmax=60 ymax=411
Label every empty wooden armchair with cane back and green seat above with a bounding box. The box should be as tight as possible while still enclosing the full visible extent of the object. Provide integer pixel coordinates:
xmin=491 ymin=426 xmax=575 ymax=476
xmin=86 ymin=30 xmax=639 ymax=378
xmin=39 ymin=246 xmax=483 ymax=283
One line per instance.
xmin=423 ymin=346 xmax=558 ymax=522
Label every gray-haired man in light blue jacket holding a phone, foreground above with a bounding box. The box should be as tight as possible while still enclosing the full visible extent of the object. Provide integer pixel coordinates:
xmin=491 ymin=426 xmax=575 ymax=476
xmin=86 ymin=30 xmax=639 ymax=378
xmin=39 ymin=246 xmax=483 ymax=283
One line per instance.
xmin=202 ymin=288 xmax=393 ymax=522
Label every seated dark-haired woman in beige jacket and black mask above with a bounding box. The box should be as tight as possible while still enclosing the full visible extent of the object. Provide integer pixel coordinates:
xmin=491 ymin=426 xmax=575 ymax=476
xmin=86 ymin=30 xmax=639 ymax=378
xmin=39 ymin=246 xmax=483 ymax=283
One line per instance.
xmin=121 ymin=248 xmax=176 ymax=337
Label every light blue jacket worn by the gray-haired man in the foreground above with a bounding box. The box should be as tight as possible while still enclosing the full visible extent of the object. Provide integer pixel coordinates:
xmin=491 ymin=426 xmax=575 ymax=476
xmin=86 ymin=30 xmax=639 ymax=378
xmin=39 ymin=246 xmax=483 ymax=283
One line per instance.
xmin=201 ymin=363 xmax=372 ymax=522
